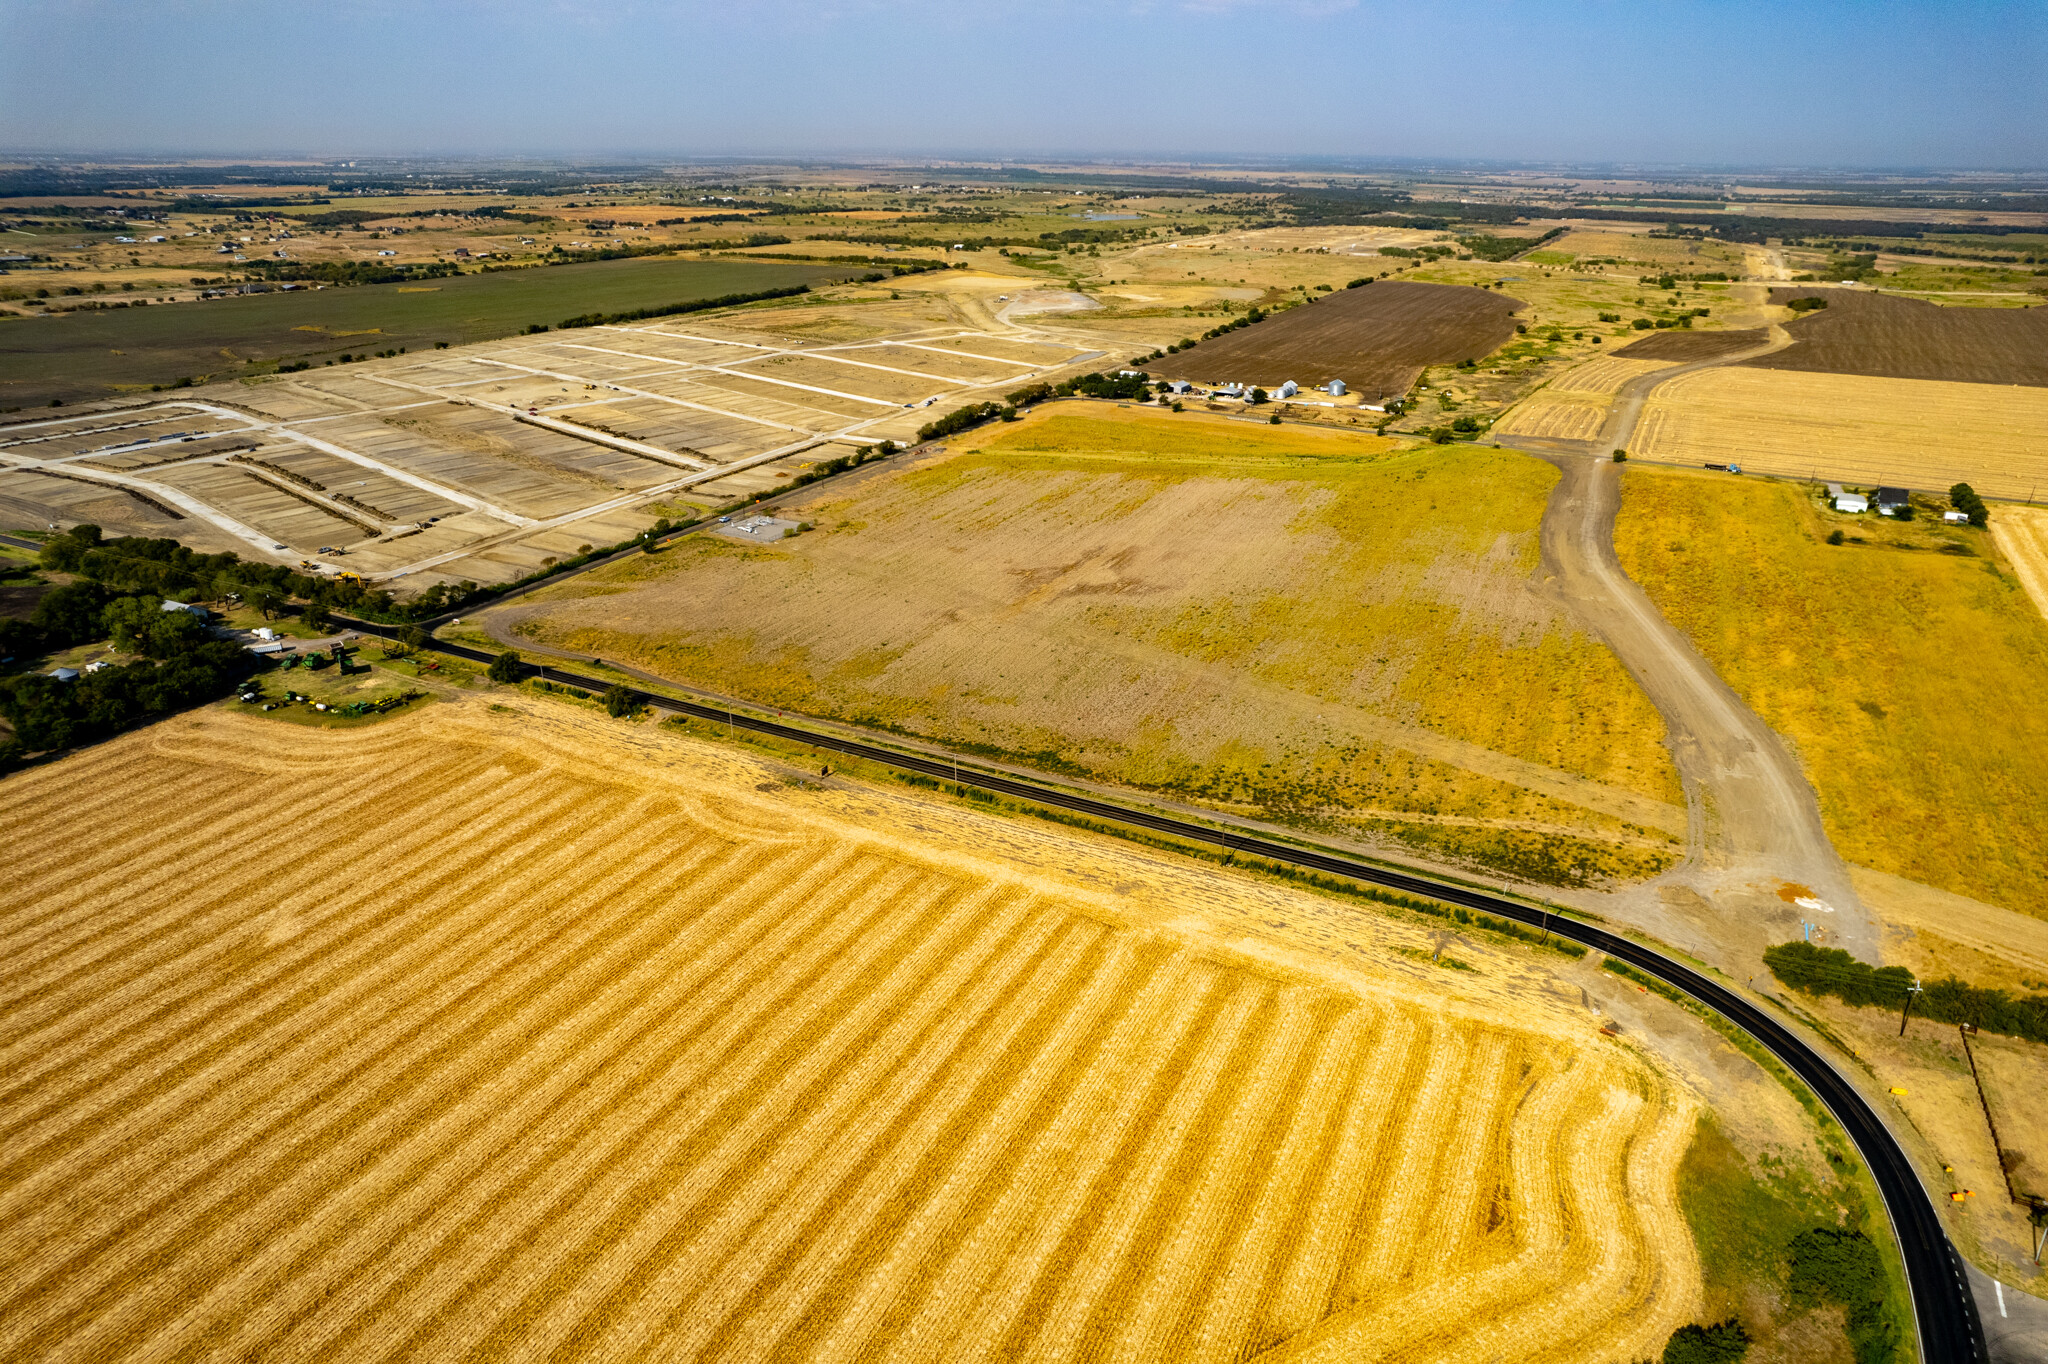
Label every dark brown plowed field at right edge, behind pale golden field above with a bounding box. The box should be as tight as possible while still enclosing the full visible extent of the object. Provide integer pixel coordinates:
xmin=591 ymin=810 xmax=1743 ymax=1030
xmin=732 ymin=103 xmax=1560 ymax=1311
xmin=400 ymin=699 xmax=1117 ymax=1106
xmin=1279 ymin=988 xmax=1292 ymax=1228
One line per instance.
xmin=1745 ymin=285 xmax=2048 ymax=387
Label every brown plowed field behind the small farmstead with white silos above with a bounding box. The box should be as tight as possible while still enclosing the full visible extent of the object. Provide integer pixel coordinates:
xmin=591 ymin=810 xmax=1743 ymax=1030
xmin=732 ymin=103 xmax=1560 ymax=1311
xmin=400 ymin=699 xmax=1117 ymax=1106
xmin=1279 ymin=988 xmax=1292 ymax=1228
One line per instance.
xmin=1147 ymin=281 xmax=1522 ymax=401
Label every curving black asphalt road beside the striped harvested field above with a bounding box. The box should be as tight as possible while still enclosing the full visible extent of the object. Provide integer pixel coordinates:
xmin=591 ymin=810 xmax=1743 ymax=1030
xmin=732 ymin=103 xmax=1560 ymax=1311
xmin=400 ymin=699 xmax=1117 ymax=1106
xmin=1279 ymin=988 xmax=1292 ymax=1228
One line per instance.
xmin=350 ymin=623 xmax=1991 ymax=1364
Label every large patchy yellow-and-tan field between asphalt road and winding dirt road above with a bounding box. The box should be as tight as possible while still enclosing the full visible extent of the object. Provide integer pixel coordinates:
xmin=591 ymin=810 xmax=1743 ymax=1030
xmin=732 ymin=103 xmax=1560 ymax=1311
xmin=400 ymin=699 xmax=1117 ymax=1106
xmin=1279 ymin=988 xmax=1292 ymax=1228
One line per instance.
xmin=473 ymin=401 xmax=1686 ymax=887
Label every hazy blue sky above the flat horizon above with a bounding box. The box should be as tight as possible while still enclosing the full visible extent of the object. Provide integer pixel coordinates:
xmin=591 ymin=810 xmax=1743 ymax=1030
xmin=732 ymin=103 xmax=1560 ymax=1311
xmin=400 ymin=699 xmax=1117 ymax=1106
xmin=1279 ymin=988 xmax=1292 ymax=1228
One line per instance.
xmin=0 ymin=0 xmax=2048 ymax=168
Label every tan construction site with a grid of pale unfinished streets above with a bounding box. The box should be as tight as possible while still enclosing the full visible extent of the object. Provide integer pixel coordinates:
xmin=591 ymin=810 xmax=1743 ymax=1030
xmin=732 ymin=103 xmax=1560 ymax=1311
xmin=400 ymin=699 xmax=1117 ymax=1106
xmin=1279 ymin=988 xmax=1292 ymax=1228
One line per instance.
xmin=0 ymin=309 xmax=1090 ymax=588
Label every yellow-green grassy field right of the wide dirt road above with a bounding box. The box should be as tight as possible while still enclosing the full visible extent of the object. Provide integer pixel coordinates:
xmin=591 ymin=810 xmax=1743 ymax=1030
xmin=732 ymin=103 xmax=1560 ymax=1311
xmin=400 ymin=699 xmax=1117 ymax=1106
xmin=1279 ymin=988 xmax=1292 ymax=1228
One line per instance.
xmin=1614 ymin=467 xmax=2048 ymax=915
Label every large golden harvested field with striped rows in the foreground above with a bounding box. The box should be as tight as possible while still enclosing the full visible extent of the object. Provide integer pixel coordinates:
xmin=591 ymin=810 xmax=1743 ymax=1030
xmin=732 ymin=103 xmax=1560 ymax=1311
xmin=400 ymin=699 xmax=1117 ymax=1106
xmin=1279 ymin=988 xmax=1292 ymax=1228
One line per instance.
xmin=0 ymin=692 xmax=1700 ymax=1364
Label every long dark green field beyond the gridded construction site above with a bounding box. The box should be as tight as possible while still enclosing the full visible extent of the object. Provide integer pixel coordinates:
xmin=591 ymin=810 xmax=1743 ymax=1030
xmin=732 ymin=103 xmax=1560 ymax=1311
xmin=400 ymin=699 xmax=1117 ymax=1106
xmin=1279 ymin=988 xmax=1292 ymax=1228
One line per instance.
xmin=0 ymin=256 xmax=856 ymax=408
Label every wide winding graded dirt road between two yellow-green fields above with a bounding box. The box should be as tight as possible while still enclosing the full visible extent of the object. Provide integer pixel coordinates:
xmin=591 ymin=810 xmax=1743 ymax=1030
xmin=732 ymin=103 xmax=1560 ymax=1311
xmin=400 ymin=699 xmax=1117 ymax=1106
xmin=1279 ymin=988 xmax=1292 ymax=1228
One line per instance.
xmin=1501 ymin=326 xmax=1884 ymax=961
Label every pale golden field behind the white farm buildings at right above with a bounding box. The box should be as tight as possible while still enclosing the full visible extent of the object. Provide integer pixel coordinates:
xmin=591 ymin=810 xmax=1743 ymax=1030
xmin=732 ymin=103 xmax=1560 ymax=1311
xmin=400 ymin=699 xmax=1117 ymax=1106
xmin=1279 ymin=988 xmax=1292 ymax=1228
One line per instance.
xmin=1632 ymin=367 xmax=2048 ymax=498
